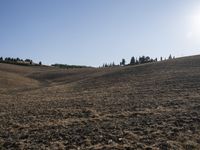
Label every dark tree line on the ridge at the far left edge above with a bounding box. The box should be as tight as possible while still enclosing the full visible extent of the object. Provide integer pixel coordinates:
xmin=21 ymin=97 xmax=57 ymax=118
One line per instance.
xmin=0 ymin=57 xmax=42 ymax=66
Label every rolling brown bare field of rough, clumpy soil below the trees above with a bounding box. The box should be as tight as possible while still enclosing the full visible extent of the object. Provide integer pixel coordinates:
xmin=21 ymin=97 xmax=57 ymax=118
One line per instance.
xmin=0 ymin=56 xmax=200 ymax=150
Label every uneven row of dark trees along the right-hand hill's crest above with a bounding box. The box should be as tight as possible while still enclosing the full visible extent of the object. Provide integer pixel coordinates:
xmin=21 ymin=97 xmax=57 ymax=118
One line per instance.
xmin=100 ymin=54 xmax=175 ymax=68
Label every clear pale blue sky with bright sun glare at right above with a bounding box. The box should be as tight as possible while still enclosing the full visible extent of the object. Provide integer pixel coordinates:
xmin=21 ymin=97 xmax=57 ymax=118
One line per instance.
xmin=0 ymin=0 xmax=200 ymax=66
